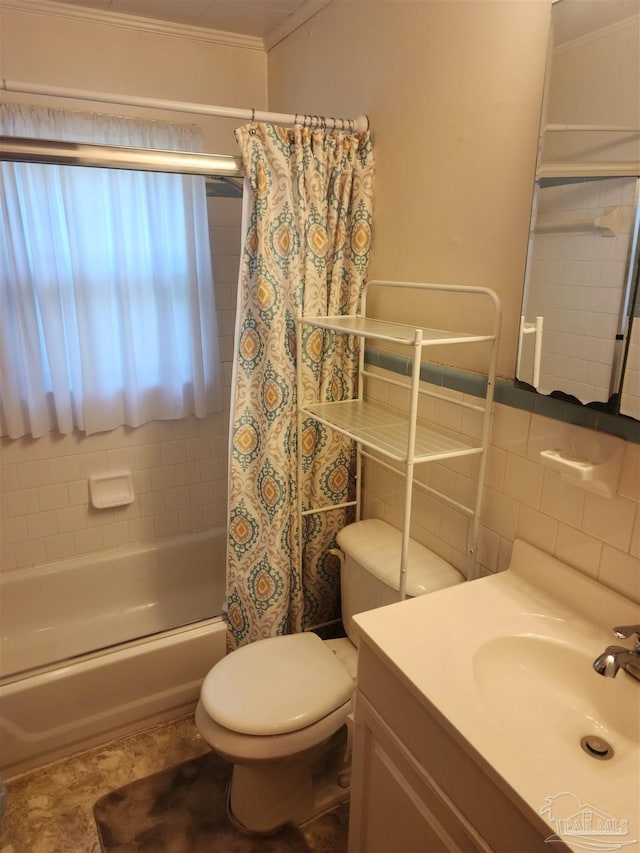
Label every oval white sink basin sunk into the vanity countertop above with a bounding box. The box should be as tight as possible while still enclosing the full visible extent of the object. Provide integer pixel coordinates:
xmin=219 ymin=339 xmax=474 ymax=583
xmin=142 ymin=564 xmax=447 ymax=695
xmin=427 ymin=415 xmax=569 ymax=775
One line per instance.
xmin=473 ymin=636 xmax=640 ymax=753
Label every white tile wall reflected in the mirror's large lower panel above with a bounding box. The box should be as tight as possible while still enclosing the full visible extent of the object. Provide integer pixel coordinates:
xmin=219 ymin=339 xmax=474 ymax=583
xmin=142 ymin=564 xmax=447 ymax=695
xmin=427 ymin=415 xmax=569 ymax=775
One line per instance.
xmin=519 ymin=177 xmax=636 ymax=403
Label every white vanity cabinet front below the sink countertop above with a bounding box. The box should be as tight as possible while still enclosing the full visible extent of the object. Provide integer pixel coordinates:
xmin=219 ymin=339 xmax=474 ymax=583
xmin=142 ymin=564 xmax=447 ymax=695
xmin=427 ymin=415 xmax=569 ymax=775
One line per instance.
xmin=348 ymin=631 xmax=568 ymax=853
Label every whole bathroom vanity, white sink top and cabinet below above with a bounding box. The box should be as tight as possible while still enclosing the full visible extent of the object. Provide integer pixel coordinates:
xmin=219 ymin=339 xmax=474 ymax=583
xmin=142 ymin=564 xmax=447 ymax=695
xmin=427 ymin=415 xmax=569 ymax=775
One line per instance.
xmin=349 ymin=542 xmax=640 ymax=853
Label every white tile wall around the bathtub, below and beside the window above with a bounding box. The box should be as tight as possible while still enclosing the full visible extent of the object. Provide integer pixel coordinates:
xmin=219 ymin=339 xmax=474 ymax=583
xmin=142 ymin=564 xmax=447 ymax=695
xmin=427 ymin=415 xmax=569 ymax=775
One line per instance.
xmin=0 ymin=198 xmax=241 ymax=571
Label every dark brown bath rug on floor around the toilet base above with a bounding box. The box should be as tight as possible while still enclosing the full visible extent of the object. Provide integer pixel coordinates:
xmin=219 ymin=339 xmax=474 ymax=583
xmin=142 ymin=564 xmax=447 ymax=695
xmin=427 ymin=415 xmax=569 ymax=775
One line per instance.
xmin=93 ymin=753 xmax=348 ymax=853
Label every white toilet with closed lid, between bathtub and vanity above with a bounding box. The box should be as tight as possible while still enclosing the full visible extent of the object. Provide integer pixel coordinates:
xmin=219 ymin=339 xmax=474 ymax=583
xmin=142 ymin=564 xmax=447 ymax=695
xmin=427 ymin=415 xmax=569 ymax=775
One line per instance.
xmin=196 ymin=519 xmax=464 ymax=832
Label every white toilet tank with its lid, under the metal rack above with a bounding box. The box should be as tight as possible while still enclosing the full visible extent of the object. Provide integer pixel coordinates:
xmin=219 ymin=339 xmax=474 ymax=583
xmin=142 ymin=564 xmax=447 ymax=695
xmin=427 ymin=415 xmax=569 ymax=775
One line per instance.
xmin=337 ymin=518 xmax=465 ymax=646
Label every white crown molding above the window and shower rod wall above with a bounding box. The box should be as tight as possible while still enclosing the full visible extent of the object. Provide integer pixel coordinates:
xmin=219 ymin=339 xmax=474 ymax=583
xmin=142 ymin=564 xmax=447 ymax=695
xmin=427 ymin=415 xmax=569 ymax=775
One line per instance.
xmin=0 ymin=0 xmax=266 ymax=51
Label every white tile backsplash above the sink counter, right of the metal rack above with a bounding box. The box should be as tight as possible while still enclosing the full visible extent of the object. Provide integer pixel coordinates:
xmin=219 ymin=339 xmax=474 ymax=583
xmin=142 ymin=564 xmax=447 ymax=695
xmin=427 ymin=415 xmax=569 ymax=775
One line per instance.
xmin=481 ymin=405 xmax=640 ymax=601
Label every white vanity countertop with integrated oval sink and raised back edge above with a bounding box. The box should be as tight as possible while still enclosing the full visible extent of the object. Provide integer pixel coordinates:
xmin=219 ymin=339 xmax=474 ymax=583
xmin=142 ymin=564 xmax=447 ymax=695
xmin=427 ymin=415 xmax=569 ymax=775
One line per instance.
xmin=356 ymin=541 xmax=640 ymax=851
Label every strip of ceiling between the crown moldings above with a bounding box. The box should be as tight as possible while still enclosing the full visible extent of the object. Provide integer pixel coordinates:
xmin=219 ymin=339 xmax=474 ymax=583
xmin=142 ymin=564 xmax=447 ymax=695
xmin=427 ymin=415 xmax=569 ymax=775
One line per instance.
xmin=33 ymin=0 xmax=330 ymax=47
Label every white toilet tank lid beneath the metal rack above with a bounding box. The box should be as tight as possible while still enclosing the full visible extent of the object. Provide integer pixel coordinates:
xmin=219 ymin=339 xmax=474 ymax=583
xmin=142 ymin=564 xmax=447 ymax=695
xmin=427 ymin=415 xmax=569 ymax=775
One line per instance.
xmin=337 ymin=518 xmax=464 ymax=596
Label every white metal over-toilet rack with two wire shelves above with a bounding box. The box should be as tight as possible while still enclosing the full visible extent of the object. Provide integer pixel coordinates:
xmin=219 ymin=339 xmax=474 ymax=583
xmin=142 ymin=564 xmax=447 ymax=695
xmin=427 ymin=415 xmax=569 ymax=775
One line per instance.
xmin=297 ymin=280 xmax=501 ymax=584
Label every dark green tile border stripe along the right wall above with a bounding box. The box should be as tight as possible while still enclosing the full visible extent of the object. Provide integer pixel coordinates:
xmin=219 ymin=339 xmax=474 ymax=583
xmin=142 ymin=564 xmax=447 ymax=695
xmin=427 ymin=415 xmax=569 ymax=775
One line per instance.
xmin=365 ymin=348 xmax=640 ymax=444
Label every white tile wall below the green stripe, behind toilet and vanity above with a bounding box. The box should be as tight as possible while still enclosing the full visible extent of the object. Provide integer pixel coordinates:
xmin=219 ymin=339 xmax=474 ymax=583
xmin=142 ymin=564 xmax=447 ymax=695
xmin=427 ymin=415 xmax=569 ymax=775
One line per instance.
xmin=363 ymin=372 xmax=640 ymax=601
